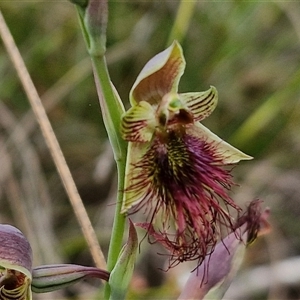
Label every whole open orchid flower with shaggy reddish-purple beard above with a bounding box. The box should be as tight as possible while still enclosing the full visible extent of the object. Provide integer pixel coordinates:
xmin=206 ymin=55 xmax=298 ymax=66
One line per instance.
xmin=121 ymin=41 xmax=251 ymax=266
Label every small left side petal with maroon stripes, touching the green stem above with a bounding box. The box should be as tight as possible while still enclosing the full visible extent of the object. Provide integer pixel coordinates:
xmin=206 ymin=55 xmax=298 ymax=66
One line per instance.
xmin=121 ymin=101 xmax=155 ymax=142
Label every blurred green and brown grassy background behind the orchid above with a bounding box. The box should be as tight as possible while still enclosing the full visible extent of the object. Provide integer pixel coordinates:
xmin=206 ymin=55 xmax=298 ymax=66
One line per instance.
xmin=0 ymin=0 xmax=300 ymax=299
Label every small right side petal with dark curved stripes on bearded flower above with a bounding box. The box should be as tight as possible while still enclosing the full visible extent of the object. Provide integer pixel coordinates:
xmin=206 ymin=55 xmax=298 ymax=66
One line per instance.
xmin=179 ymin=86 xmax=218 ymax=121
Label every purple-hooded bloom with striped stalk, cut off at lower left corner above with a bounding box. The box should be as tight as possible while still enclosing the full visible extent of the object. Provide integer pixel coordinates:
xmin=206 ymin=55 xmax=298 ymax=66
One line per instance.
xmin=0 ymin=224 xmax=110 ymax=300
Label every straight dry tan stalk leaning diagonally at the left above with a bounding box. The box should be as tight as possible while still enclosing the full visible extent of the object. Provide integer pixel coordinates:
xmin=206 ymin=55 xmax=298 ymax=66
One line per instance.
xmin=0 ymin=11 xmax=106 ymax=269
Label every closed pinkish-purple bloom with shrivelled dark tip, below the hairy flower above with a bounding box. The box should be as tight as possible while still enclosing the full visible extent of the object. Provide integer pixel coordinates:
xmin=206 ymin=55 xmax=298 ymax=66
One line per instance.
xmin=178 ymin=200 xmax=271 ymax=300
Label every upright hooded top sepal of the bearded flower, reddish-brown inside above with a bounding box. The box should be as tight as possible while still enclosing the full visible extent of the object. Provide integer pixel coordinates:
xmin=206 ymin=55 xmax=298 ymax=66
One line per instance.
xmin=129 ymin=41 xmax=185 ymax=105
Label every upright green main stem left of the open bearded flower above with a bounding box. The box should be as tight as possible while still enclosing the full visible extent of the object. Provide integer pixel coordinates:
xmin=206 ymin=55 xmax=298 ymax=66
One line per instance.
xmin=77 ymin=6 xmax=127 ymax=299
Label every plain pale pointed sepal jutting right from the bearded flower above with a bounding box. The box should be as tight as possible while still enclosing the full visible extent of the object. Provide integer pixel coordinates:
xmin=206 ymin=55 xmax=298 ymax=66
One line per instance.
xmin=187 ymin=122 xmax=252 ymax=164
